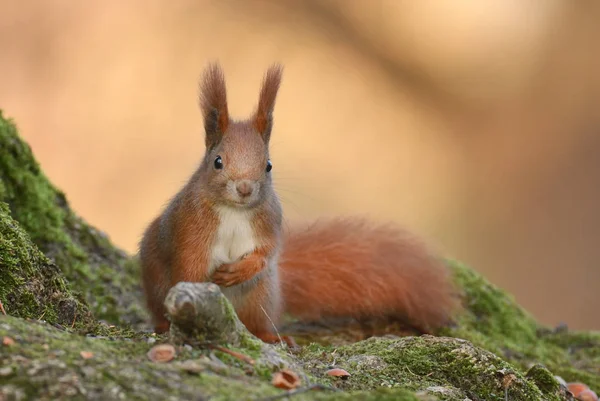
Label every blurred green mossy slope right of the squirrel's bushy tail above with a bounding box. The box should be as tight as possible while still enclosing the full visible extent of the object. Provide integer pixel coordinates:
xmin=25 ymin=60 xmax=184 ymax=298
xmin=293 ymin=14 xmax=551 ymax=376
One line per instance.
xmin=442 ymin=261 xmax=600 ymax=389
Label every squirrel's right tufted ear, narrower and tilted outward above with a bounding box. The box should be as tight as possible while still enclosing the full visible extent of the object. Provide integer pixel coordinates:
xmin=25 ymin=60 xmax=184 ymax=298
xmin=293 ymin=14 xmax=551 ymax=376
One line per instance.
xmin=252 ymin=64 xmax=283 ymax=143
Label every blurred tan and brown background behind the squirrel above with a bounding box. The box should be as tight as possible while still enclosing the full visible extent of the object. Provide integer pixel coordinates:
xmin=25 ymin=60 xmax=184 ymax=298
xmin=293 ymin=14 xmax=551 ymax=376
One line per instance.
xmin=0 ymin=0 xmax=600 ymax=329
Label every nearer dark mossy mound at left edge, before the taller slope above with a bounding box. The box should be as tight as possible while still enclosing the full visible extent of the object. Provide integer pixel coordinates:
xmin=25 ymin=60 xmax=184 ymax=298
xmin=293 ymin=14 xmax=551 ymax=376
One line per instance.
xmin=0 ymin=202 xmax=92 ymax=328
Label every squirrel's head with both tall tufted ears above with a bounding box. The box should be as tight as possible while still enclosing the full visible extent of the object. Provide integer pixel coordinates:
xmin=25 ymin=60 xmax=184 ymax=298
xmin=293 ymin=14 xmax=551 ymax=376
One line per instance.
xmin=200 ymin=63 xmax=282 ymax=208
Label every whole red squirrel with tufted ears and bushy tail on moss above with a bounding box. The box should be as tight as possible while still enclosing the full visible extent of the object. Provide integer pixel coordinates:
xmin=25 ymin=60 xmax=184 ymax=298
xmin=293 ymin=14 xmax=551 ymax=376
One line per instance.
xmin=139 ymin=63 xmax=457 ymax=344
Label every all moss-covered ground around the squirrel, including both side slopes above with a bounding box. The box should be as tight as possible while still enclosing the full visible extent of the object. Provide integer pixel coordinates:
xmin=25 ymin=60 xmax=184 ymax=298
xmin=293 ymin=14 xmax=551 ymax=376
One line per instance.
xmin=0 ymin=108 xmax=600 ymax=401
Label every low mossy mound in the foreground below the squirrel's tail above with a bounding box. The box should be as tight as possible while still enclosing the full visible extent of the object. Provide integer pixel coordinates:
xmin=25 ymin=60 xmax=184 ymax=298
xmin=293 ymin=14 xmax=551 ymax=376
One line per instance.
xmin=301 ymin=336 xmax=560 ymax=400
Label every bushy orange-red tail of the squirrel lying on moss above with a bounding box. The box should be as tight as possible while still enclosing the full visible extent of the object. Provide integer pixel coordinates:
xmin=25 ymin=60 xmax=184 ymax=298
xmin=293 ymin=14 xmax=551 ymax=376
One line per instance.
xmin=280 ymin=218 xmax=458 ymax=332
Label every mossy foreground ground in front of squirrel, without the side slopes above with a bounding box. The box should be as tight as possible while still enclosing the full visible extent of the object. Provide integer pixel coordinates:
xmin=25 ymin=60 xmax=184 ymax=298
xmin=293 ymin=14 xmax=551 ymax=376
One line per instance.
xmin=0 ymin=308 xmax=567 ymax=401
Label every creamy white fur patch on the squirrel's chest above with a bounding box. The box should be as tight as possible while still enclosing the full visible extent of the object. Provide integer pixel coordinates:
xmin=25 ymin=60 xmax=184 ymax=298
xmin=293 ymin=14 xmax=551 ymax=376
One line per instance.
xmin=210 ymin=207 xmax=256 ymax=273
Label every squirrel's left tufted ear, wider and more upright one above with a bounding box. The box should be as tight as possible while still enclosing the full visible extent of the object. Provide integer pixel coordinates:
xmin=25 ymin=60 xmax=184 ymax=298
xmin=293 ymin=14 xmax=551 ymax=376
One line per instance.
xmin=200 ymin=62 xmax=229 ymax=149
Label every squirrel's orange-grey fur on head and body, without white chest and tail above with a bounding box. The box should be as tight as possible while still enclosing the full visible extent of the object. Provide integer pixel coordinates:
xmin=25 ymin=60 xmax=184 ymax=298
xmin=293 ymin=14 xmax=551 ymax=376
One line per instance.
xmin=140 ymin=64 xmax=282 ymax=339
